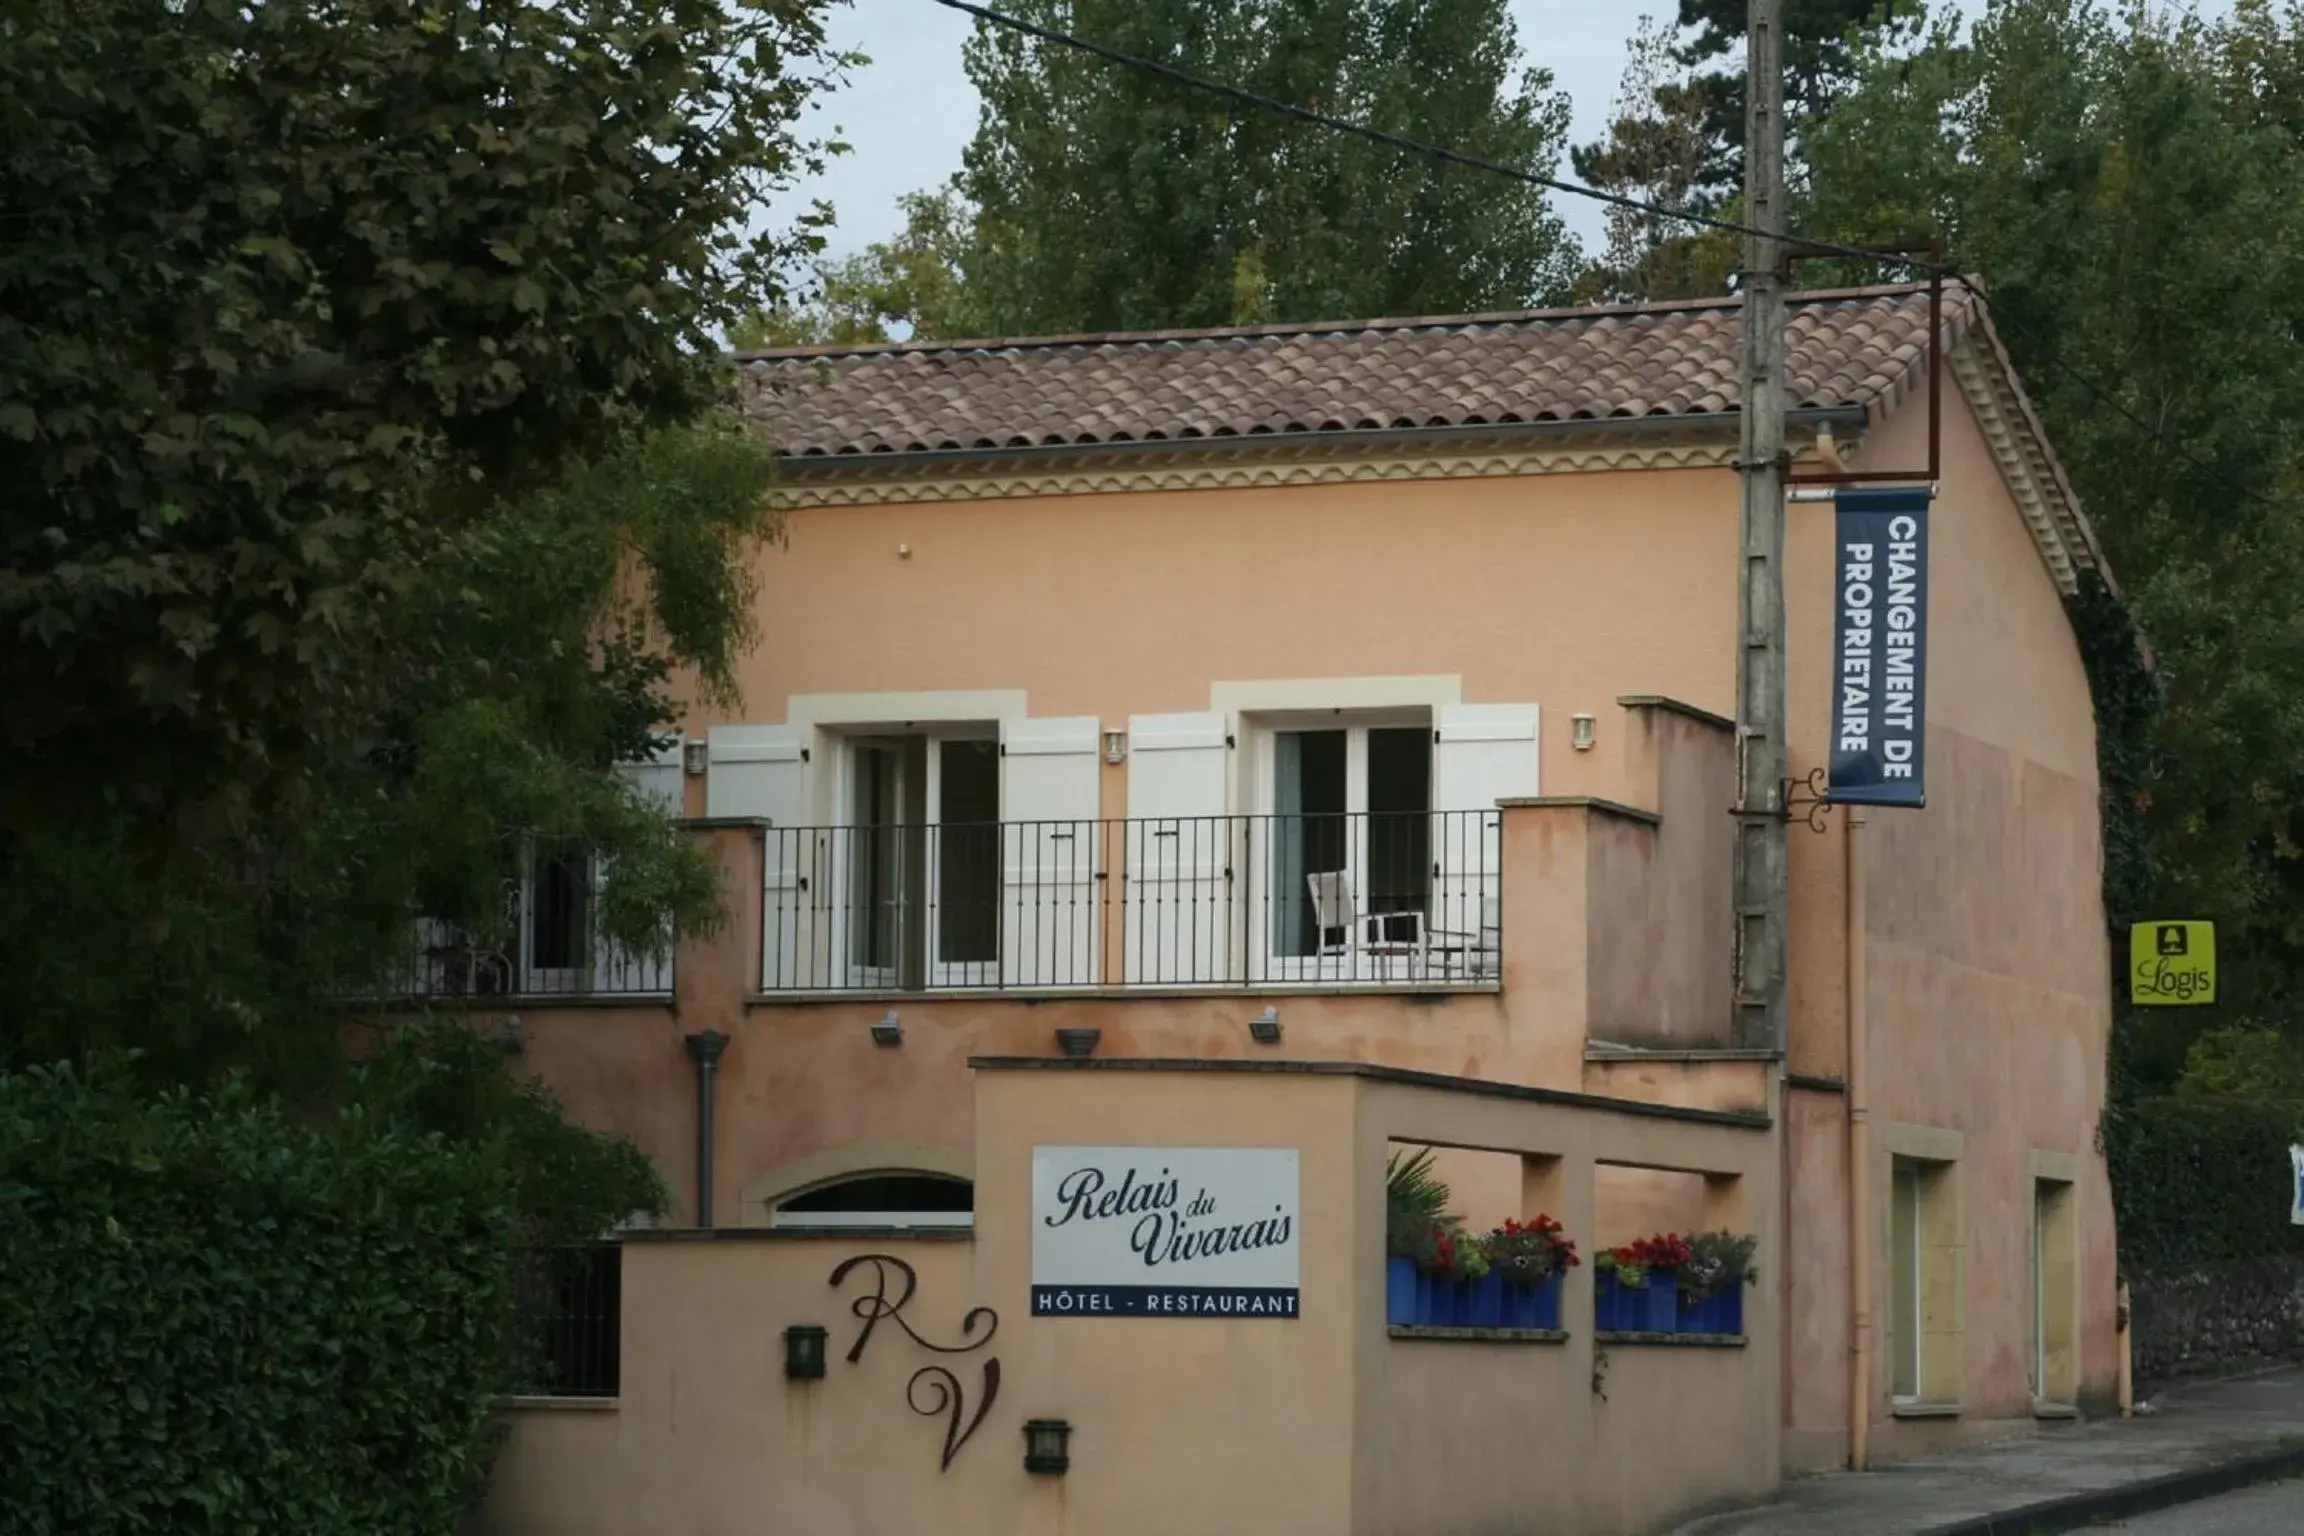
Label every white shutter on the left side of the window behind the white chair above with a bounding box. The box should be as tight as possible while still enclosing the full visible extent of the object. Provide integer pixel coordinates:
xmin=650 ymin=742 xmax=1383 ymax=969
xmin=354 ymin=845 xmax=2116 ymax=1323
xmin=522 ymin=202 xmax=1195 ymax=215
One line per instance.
xmin=1120 ymin=714 xmax=1240 ymax=986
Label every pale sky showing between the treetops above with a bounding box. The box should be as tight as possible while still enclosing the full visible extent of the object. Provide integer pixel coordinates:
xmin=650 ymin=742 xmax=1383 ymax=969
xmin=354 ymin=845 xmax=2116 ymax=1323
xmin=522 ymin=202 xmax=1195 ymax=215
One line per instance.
xmin=790 ymin=0 xmax=2230 ymax=256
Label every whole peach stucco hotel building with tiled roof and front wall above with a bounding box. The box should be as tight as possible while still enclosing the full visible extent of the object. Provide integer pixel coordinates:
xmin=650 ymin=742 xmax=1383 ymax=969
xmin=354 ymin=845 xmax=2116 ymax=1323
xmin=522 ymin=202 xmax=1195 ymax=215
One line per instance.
xmin=463 ymin=288 xmax=2122 ymax=1536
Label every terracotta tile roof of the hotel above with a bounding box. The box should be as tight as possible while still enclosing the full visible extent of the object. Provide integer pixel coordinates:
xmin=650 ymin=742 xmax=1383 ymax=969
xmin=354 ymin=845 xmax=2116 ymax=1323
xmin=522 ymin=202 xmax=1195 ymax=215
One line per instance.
xmin=737 ymin=286 xmax=1977 ymax=461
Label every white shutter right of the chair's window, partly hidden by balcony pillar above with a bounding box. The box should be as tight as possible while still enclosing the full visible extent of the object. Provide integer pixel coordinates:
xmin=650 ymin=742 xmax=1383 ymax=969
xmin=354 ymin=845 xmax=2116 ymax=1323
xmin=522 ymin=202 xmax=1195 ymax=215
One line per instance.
xmin=1431 ymin=705 xmax=1539 ymax=979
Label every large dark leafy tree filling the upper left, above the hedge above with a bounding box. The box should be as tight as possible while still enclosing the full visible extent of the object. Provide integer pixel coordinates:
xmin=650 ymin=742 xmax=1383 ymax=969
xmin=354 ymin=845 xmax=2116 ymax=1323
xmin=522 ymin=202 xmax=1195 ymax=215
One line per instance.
xmin=0 ymin=0 xmax=846 ymax=1082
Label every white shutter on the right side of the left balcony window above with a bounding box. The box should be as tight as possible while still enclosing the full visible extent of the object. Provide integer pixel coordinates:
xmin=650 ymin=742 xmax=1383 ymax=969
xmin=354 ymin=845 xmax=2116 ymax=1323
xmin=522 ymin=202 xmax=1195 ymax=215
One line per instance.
xmin=1000 ymin=714 xmax=1101 ymax=988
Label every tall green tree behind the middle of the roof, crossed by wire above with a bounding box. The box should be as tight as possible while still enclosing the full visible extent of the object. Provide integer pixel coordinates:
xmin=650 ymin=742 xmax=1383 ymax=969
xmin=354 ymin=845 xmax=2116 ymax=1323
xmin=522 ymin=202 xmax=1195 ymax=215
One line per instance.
xmin=915 ymin=0 xmax=1574 ymax=334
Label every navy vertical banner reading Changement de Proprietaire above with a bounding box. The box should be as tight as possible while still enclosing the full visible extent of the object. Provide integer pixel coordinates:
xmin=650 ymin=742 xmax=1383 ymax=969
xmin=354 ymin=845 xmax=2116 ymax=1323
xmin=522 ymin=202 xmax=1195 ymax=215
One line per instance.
xmin=1825 ymin=491 xmax=1928 ymax=806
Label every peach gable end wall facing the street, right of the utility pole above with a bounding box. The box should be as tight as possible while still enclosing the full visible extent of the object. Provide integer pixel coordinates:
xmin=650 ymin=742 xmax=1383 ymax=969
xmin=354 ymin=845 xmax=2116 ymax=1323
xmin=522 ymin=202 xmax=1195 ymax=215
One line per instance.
xmin=1786 ymin=363 xmax=2117 ymax=1469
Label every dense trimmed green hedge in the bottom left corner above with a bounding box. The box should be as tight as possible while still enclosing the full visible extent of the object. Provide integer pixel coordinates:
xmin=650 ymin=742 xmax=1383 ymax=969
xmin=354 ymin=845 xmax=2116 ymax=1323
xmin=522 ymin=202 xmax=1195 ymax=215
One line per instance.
xmin=0 ymin=1069 xmax=509 ymax=1536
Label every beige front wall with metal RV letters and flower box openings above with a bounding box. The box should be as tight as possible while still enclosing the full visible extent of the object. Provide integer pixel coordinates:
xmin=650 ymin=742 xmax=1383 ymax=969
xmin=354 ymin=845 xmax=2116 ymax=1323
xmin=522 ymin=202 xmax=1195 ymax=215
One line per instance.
xmin=479 ymin=1059 xmax=1781 ymax=1536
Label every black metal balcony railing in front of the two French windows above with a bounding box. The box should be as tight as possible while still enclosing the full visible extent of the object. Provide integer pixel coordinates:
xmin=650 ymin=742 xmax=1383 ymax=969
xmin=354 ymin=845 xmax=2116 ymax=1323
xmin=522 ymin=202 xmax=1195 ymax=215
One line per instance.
xmin=760 ymin=811 xmax=1502 ymax=993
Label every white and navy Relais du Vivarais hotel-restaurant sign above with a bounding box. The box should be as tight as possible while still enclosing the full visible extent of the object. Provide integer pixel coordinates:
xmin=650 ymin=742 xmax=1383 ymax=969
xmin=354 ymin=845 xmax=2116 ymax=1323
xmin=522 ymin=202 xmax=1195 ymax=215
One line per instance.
xmin=1032 ymin=1147 xmax=1299 ymax=1317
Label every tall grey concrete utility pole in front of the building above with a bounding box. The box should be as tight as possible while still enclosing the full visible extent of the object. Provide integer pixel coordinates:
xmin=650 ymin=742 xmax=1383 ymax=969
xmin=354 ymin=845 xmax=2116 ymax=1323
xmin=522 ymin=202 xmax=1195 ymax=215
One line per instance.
xmin=1735 ymin=0 xmax=1788 ymax=1050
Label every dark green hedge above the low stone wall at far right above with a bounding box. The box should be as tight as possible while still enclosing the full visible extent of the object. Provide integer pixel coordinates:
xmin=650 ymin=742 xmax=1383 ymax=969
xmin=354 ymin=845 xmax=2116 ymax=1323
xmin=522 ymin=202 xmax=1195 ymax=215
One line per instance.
xmin=2104 ymin=1098 xmax=2304 ymax=1271
